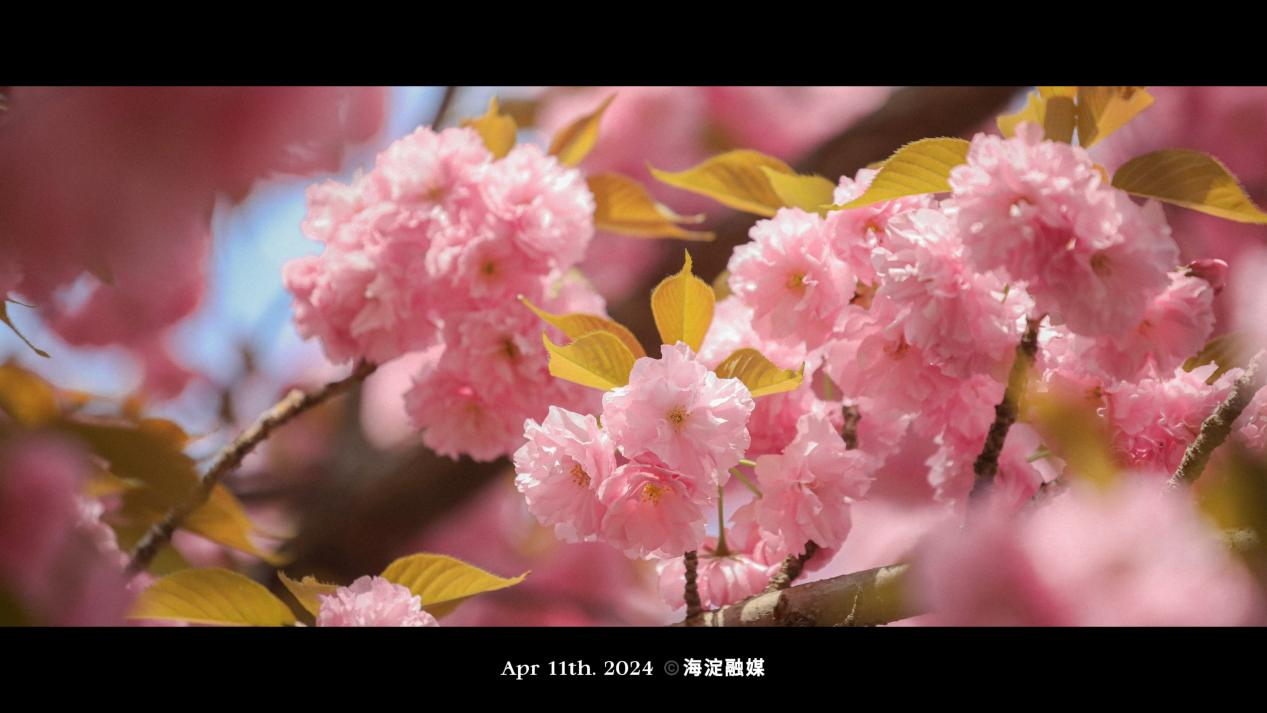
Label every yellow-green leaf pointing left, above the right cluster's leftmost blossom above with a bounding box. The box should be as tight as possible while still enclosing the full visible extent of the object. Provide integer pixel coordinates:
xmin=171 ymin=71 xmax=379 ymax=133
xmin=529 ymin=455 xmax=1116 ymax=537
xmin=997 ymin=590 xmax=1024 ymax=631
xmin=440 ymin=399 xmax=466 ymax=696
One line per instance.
xmin=651 ymin=148 xmax=794 ymax=218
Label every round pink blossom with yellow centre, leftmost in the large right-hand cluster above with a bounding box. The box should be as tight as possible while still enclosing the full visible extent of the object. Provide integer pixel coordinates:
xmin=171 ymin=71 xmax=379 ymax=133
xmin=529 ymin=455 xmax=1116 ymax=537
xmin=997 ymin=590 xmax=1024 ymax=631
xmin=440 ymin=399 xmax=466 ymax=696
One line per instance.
xmin=730 ymin=208 xmax=855 ymax=348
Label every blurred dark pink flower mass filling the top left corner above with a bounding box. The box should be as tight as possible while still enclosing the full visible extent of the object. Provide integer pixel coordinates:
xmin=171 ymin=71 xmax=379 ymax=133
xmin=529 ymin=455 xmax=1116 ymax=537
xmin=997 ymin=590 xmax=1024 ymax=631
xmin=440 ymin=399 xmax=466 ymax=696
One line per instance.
xmin=0 ymin=87 xmax=384 ymax=398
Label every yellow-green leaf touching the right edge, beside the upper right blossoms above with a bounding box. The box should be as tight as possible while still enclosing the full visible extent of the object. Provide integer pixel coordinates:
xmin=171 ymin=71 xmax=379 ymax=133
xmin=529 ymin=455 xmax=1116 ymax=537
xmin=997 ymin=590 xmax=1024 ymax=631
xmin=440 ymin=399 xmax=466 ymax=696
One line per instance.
xmin=1112 ymin=148 xmax=1267 ymax=225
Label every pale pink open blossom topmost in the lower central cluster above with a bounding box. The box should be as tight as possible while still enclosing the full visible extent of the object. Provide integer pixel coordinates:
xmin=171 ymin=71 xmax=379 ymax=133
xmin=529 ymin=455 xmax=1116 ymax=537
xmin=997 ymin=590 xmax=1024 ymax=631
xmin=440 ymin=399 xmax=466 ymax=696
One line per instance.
xmin=603 ymin=342 xmax=754 ymax=488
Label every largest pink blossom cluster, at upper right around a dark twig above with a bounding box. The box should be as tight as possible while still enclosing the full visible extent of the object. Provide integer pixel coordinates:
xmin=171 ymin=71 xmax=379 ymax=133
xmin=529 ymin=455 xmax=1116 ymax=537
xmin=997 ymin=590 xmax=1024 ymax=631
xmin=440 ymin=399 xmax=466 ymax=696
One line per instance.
xmin=730 ymin=124 xmax=1237 ymax=504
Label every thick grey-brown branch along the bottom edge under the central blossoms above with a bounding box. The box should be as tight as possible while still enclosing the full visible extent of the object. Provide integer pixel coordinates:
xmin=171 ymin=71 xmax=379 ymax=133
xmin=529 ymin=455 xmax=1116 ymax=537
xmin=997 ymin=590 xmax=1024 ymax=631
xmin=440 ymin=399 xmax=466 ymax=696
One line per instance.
xmin=696 ymin=565 xmax=920 ymax=627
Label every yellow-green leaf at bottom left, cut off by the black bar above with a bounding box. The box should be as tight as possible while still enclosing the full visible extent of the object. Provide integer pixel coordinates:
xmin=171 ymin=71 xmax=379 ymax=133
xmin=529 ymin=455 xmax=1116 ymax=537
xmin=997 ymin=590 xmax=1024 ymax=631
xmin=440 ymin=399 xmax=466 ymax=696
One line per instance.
xmin=129 ymin=567 xmax=295 ymax=627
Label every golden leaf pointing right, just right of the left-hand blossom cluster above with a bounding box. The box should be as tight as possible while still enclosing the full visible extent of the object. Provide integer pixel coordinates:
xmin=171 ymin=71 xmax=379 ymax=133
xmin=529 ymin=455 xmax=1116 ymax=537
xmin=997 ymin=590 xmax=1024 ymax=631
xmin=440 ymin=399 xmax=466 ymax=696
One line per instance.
xmin=585 ymin=174 xmax=713 ymax=241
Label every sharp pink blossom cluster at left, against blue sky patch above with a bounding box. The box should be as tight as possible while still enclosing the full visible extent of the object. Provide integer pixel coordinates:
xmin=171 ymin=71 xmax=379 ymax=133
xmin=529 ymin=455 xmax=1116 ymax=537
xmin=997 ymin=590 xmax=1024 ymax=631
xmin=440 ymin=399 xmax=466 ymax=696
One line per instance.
xmin=284 ymin=128 xmax=604 ymax=461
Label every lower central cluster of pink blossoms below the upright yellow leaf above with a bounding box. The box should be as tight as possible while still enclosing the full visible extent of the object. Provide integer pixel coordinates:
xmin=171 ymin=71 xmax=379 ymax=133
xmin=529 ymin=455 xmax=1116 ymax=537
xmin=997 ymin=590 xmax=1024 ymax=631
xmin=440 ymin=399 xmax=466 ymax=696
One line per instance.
xmin=514 ymin=329 xmax=870 ymax=605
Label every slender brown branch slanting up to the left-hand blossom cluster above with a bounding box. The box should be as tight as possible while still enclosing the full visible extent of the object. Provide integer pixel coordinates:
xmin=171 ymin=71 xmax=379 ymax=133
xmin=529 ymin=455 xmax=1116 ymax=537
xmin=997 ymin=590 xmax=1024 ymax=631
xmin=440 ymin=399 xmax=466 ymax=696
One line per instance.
xmin=128 ymin=361 xmax=376 ymax=574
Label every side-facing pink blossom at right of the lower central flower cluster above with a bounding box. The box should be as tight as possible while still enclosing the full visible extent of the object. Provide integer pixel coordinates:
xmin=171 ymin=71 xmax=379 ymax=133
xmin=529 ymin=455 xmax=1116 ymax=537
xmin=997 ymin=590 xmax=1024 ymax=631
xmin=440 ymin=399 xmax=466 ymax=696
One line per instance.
xmin=756 ymin=409 xmax=874 ymax=550
